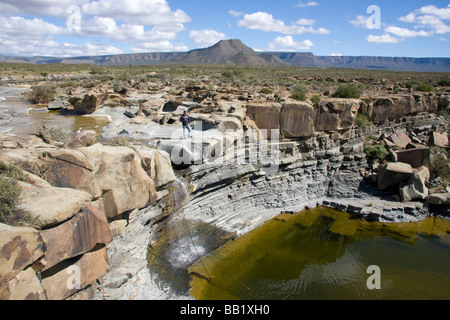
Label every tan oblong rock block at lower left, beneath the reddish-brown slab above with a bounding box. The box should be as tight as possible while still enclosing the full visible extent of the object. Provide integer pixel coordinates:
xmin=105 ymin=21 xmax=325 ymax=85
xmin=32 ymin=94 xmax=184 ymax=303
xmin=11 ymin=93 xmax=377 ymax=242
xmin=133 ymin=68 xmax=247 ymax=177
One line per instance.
xmin=41 ymin=247 xmax=109 ymax=300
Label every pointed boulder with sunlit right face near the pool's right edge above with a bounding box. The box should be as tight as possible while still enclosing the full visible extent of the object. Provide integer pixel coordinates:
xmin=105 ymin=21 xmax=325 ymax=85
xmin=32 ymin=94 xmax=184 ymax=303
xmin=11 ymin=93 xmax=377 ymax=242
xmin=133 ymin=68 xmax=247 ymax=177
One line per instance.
xmin=400 ymin=167 xmax=430 ymax=202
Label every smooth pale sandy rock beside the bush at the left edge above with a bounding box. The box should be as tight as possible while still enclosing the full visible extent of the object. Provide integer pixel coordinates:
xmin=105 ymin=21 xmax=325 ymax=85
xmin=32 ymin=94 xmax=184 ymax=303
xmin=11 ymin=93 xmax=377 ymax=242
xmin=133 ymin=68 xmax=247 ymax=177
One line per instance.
xmin=18 ymin=181 xmax=92 ymax=228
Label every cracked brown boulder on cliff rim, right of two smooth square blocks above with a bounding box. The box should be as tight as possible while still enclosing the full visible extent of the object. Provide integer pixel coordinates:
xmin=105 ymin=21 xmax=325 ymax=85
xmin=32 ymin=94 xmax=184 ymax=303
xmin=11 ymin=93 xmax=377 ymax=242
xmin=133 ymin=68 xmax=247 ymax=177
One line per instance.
xmin=314 ymin=99 xmax=359 ymax=131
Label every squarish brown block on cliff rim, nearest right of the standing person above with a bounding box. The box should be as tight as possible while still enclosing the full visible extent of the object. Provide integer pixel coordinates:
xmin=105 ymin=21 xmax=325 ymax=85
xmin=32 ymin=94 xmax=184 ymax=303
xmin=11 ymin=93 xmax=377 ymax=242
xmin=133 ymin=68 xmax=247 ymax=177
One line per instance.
xmin=247 ymin=103 xmax=281 ymax=139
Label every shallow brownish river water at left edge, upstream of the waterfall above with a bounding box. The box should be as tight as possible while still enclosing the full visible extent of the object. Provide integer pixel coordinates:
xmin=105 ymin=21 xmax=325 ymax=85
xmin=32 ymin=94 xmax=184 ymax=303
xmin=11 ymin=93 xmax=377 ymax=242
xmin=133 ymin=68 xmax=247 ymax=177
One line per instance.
xmin=0 ymin=98 xmax=108 ymax=135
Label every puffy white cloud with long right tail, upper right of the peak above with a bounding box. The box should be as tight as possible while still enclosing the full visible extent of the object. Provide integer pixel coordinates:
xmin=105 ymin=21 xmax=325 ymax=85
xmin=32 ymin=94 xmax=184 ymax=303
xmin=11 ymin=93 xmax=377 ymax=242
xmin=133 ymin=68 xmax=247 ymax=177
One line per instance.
xmin=238 ymin=11 xmax=330 ymax=34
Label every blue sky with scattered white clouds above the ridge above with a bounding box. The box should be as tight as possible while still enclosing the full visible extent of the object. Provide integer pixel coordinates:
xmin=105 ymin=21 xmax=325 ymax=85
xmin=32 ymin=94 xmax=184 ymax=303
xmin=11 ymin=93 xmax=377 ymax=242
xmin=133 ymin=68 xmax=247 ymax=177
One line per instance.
xmin=0 ymin=0 xmax=450 ymax=57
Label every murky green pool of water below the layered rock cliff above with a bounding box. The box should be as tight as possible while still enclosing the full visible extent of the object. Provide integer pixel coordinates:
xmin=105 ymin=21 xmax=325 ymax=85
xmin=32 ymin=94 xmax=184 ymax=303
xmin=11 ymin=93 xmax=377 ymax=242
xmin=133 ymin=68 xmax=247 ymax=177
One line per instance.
xmin=189 ymin=208 xmax=450 ymax=300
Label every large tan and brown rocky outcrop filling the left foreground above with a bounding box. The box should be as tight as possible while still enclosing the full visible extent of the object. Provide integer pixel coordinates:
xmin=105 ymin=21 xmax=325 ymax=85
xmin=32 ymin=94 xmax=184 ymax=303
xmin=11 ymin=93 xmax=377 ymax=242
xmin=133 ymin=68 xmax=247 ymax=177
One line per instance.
xmin=0 ymin=133 xmax=176 ymax=300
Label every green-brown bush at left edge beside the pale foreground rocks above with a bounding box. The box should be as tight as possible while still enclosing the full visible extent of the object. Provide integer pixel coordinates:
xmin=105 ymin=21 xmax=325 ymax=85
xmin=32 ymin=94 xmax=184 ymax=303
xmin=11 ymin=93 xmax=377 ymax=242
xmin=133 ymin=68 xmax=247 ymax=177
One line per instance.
xmin=0 ymin=161 xmax=30 ymax=226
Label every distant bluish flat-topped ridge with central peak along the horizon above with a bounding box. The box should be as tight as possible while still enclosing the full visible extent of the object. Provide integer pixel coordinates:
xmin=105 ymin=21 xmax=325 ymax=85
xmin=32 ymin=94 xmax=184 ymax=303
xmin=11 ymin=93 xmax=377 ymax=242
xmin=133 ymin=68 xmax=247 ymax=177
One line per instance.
xmin=0 ymin=39 xmax=450 ymax=72
